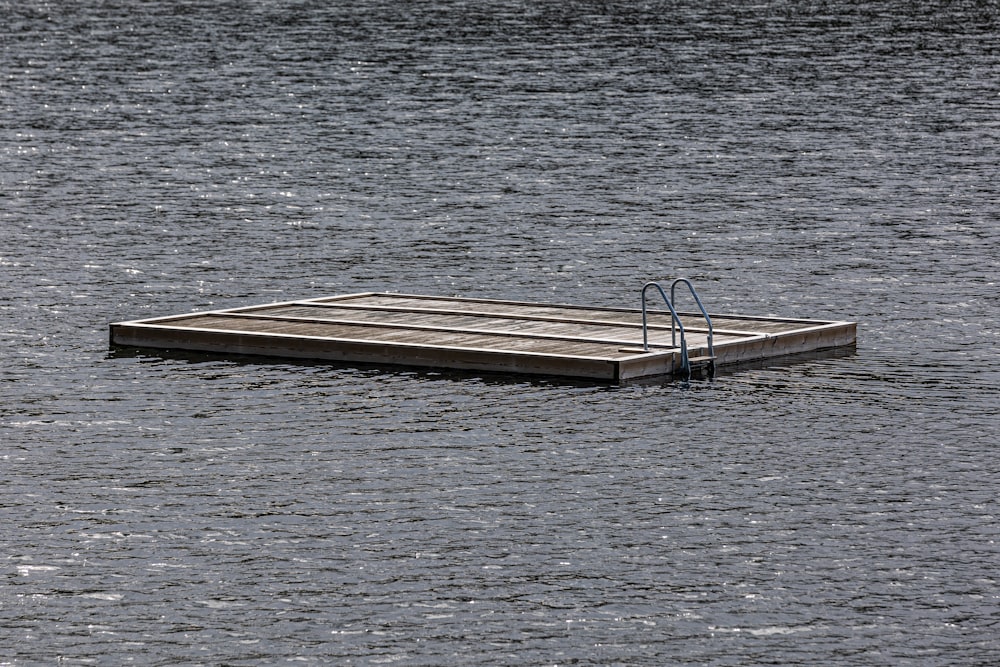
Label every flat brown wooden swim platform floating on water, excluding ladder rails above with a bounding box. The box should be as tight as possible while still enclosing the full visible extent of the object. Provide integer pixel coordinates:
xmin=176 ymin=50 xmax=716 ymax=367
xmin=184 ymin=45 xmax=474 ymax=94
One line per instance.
xmin=110 ymin=292 xmax=857 ymax=382
